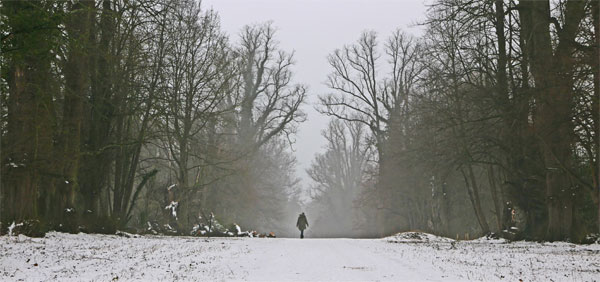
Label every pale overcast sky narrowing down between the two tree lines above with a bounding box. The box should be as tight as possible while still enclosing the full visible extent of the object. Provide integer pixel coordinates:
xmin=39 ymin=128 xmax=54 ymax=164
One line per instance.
xmin=202 ymin=0 xmax=427 ymax=187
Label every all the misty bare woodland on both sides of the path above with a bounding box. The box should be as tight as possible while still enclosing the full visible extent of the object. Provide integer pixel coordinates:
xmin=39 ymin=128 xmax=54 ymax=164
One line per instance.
xmin=0 ymin=0 xmax=600 ymax=242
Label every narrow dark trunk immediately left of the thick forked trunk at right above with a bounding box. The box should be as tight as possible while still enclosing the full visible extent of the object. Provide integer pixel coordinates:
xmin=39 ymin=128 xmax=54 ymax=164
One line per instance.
xmin=503 ymin=0 xmax=546 ymax=238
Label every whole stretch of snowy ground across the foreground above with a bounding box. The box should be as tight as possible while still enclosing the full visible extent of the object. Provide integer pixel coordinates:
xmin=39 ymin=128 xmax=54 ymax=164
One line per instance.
xmin=0 ymin=232 xmax=600 ymax=281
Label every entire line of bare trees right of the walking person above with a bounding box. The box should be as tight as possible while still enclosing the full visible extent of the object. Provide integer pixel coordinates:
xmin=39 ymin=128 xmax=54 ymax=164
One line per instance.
xmin=308 ymin=0 xmax=600 ymax=241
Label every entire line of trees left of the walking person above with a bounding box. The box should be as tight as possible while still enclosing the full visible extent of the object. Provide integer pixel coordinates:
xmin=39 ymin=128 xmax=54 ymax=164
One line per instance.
xmin=0 ymin=0 xmax=307 ymax=235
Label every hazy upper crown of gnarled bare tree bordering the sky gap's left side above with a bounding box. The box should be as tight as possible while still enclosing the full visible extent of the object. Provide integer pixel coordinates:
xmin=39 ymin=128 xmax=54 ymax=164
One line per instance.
xmin=235 ymin=23 xmax=306 ymax=149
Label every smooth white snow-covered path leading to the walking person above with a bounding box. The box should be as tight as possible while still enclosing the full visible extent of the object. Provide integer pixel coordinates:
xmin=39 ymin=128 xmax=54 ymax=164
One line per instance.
xmin=230 ymin=239 xmax=434 ymax=281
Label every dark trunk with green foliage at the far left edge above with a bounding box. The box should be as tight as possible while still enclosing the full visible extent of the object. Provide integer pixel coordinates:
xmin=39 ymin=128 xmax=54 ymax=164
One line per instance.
xmin=0 ymin=1 xmax=58 ymax=233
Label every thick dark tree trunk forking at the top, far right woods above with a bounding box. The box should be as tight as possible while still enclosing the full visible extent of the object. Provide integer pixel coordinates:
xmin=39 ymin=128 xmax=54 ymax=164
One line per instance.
xmin=520 ymin=0 xmax=585 ymax=240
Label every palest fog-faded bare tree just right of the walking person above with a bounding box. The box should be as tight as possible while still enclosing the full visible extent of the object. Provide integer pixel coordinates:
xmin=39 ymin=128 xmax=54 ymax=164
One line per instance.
xmin=307 ymin=119 xmax=373 ymax=236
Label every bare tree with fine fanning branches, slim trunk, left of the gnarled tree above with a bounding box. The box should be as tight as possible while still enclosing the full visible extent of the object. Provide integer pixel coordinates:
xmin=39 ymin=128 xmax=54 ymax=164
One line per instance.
xmin=159 ymin=1 xmax=233 ymax=231
